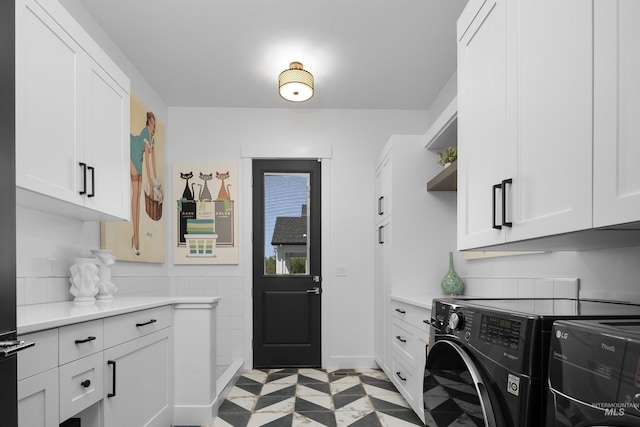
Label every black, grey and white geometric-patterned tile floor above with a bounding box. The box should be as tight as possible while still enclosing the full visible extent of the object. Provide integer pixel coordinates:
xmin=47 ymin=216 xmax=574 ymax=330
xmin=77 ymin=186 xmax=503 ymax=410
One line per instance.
xmin=207 ymin=369 xmax=424 ymax=427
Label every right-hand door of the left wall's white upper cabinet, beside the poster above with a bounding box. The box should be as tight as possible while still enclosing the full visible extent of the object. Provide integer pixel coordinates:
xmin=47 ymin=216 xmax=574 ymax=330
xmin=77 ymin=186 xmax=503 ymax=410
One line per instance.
xmin=84 ymin=58 xmax=130 ymax=220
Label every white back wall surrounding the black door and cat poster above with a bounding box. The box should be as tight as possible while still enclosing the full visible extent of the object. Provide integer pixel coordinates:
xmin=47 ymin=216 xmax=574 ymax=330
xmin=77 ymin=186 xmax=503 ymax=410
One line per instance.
xmin=167 ymin=108 xmax=428 ymax=367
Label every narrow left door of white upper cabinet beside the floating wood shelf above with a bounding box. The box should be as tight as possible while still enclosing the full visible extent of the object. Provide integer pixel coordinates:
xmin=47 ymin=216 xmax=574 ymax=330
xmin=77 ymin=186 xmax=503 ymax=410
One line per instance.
xmin=458 ymin=0 xmax=506 ymax=249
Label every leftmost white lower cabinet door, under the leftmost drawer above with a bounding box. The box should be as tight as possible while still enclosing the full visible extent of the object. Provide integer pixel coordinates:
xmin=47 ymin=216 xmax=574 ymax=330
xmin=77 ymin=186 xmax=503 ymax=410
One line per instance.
xmin=18 ymin=368 xmax=59 ymax=427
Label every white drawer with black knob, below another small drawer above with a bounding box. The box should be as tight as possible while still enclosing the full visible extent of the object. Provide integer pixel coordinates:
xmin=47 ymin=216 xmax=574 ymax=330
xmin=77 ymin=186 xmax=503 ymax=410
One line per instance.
xmin=59 ymin=352 xmax=104 ymax=422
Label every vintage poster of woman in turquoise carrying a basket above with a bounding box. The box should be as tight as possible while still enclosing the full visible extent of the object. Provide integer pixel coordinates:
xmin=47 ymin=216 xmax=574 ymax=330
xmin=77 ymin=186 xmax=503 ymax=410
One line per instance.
xmin=100 ymin=93 xmax=166 ymax=263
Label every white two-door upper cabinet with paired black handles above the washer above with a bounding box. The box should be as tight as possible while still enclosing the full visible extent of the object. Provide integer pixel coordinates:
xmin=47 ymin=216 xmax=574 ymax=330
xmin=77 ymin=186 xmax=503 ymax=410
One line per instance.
xmin=458 ymin=0 xmax=593 ymax=249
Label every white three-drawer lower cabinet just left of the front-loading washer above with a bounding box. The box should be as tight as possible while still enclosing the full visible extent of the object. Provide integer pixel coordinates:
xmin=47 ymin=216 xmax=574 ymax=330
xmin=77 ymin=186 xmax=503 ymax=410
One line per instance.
xmin=385 ymin=297 xmax=431 ymax=422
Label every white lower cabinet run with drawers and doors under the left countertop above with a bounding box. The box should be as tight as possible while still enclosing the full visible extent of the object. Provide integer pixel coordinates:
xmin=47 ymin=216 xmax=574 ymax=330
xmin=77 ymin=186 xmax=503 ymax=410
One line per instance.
xmin=18 ymin=305 xmax=175 ymax=427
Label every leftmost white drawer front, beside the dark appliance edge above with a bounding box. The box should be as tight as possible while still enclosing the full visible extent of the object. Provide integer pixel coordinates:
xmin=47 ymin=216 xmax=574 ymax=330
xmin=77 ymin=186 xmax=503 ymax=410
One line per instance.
xmin=18 ymin=329 xmax=58 ymax=380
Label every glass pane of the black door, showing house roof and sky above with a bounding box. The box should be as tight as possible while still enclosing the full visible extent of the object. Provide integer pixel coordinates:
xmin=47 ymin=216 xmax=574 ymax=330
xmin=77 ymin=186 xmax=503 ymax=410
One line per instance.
xmin=264 ymin=173 xmax=311 ymax=275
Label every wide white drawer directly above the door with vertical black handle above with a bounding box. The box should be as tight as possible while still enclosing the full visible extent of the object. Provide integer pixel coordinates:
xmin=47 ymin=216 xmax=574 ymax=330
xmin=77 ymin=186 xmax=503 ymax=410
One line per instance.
xmin=104 ymin=306 xmax=172 ymax=348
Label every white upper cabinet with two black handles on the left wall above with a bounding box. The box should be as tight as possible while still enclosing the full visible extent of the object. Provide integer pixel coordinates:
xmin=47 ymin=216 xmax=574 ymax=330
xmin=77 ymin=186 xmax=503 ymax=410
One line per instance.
xmin=16 ymin=0 xmax=129 ymax=219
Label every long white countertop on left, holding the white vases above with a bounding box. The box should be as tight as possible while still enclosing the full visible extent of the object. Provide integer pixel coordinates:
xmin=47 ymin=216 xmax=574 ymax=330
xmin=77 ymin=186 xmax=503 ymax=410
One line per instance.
xmin=16 ymin=297 xmax=220 ymax=335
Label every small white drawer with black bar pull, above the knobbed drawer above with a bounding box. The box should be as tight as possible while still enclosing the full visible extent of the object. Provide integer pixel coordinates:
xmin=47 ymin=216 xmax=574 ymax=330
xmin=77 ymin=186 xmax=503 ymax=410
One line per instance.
xmin=58 ymin=319 xmax=104 ymax=365
